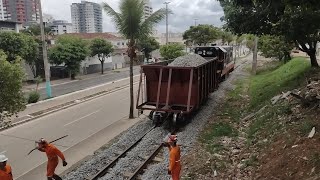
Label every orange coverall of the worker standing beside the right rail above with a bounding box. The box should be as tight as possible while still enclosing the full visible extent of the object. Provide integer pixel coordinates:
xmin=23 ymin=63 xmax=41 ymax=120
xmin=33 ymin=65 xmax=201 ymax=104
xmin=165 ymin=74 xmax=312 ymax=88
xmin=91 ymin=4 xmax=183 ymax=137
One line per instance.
xmin=169 ymin=145 xmax=181 ymax=180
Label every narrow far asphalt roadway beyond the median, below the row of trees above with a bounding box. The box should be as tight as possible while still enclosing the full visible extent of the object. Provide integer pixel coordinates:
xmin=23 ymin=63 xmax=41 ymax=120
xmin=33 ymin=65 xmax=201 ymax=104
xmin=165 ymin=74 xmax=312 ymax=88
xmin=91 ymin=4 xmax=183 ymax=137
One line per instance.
xmin=39 ymin=66 xmax=140 ymax=100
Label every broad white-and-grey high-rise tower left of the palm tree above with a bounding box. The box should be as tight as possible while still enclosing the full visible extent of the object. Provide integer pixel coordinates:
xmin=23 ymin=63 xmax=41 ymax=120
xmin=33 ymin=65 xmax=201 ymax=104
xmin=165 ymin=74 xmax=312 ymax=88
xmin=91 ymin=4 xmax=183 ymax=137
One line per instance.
xmin=71 ymin=0 xmax=102 ymax=33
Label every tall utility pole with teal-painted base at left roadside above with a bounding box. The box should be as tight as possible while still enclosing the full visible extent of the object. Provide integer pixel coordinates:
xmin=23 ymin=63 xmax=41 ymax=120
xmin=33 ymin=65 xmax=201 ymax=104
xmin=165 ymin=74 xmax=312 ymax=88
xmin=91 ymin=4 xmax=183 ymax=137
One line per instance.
xmin=38 ymin=0 xmax=52 ymax=98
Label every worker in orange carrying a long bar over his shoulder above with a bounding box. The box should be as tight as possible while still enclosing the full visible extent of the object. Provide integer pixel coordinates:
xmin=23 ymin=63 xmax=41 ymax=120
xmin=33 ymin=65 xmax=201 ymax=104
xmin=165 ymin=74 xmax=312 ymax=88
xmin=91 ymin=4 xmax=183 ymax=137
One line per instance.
xmin=37 ymin=138 xmax=68 ymax=180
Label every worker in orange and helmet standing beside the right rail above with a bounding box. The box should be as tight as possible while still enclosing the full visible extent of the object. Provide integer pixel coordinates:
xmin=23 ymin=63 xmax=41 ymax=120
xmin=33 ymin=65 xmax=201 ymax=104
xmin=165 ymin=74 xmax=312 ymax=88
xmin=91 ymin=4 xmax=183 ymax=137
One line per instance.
xmin=164 ymin=135 xmax=181 ymax=180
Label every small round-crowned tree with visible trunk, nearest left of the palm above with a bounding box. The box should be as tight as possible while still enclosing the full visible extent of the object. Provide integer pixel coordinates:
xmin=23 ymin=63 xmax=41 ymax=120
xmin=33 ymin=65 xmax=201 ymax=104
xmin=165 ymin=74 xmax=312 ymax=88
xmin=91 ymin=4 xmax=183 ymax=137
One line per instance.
xmin=90 ymin=38 xmax=113 ymax=74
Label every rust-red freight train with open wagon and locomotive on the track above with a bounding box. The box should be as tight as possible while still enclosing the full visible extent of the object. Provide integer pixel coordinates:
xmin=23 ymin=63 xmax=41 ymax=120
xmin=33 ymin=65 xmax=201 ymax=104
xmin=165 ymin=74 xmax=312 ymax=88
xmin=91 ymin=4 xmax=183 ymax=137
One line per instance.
xmin=136 ymin=46 xmax=235 ymax=126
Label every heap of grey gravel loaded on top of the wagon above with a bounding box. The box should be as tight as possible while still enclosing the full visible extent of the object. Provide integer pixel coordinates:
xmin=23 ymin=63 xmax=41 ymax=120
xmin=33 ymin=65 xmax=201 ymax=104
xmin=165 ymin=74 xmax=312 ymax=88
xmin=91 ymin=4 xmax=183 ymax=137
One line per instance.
xmin=168 ymin=54 xmax=208 ymax=67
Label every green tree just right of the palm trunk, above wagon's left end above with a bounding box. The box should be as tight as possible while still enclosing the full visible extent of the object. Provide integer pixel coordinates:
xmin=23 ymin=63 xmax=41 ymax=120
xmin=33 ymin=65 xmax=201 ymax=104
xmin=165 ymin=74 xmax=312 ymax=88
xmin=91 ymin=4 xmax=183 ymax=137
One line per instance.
xmin=137 ymin=37 xmax=160 ymax=60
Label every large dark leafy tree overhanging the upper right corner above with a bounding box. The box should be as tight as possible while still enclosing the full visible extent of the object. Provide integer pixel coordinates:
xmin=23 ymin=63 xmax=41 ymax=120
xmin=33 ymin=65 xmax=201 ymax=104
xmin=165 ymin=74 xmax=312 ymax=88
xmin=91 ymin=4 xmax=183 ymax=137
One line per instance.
xmin=219 ymin=0 xmax=320 ymax=67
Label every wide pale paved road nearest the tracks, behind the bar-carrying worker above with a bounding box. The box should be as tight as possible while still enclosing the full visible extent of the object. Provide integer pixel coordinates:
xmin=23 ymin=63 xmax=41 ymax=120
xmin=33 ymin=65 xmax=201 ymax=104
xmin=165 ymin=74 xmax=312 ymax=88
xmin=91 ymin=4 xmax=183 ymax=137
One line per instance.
xmin=0 ymin=80 xmax=138 ymax=180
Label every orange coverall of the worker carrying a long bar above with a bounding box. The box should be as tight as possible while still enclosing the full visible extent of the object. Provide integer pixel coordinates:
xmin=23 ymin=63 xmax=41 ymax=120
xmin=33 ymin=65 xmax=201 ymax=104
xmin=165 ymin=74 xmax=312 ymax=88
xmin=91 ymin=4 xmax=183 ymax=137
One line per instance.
xmin=41 ymin=144 xmax=65 ymax=177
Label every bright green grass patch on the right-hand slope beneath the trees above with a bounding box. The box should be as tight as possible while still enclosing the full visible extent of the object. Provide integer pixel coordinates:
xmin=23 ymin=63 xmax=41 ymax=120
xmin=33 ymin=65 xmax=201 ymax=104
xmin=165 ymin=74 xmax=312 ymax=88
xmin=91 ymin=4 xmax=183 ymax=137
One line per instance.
xmin=249 ymin=58 xmax=311 ymax=108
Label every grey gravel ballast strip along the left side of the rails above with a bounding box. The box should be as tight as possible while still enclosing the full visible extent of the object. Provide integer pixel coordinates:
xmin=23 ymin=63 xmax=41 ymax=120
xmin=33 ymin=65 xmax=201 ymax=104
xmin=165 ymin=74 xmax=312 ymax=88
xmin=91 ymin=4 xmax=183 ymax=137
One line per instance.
xmin=62 ymin=120 xmax=153 ymax=180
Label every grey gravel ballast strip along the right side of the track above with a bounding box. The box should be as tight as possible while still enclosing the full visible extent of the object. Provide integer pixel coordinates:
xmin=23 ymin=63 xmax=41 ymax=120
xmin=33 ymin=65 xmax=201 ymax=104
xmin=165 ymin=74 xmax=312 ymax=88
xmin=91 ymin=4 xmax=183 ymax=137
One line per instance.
xmin=142 ymin=55 xmax=251 ymax=180
